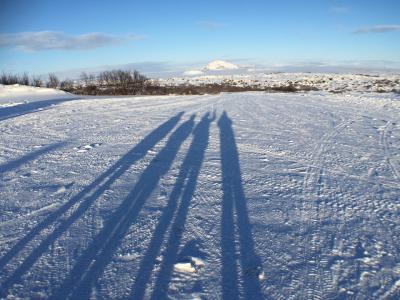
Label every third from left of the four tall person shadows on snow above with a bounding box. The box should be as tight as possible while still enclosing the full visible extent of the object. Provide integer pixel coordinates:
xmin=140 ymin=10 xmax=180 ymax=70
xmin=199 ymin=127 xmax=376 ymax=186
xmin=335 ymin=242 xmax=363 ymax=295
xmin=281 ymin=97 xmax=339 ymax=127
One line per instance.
xmin=129 ymin=113 xmax=215 ymax=299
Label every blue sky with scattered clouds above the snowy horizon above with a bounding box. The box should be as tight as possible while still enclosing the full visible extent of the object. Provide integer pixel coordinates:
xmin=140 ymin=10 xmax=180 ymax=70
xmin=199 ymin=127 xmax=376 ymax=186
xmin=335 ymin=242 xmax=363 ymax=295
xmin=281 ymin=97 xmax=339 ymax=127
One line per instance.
xmin=0 ymin=0 xmax=400 ymax=74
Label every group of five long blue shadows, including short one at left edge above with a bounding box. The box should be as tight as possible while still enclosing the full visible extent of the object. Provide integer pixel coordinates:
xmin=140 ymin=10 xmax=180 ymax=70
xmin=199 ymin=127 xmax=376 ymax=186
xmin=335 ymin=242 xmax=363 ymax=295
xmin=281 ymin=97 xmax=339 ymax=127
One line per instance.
xmin=0 ymin=112 xmax=264 ymax=299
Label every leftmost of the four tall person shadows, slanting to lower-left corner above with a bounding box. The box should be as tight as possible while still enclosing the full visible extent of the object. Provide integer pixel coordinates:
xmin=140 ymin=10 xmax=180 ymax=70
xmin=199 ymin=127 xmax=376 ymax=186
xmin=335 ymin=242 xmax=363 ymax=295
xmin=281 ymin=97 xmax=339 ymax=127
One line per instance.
xmin=0 ymin=112 xmax=183 ymax=297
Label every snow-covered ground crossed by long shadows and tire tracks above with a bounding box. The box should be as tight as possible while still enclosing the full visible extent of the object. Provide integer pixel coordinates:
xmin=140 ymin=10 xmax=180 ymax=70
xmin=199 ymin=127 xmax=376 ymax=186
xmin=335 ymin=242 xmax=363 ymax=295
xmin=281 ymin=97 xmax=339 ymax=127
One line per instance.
xmin=0 ymin=78 xmax=400 ymax=299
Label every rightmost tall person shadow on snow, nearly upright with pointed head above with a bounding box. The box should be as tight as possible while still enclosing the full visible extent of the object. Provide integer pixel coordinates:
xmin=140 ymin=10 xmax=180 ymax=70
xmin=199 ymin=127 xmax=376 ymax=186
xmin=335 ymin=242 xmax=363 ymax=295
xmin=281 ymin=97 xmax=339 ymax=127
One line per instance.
xmin=218 ymin=112 xmax=264 ymax=299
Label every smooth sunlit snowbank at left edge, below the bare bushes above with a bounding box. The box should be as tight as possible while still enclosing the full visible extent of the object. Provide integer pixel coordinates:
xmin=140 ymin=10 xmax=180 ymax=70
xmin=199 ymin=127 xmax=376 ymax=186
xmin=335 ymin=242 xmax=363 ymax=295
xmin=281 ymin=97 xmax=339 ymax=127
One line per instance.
xmin=0 ymin=84 xmax=71 ymax=103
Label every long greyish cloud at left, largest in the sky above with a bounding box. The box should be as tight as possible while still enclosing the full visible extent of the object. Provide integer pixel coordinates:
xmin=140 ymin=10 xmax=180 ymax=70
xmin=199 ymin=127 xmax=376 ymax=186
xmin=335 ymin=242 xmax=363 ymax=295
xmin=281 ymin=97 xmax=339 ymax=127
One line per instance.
xmin=0 ymin=31 xmax=143 ymax=51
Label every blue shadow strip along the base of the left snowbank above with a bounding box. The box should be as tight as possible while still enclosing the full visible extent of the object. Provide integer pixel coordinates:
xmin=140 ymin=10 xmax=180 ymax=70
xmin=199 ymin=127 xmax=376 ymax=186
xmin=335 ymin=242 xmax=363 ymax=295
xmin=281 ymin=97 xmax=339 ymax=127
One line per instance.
xmin=0 ymin=97 xmax=82 ymax=121
